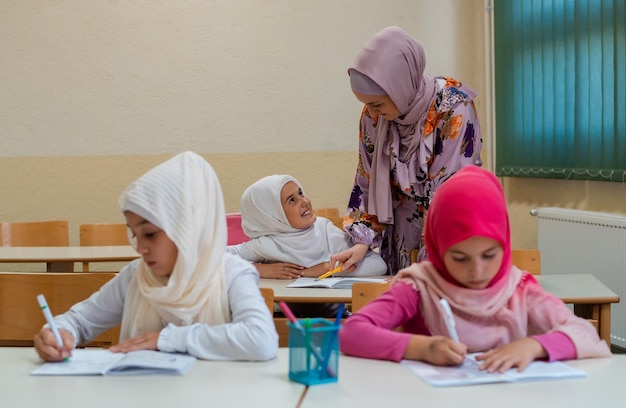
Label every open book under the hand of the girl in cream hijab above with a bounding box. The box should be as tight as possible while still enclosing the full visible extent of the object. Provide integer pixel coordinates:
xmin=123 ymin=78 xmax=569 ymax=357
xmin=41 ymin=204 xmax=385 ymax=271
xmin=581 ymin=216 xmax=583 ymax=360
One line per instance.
xmin=31 ymin=349 xmax=197 ymax=375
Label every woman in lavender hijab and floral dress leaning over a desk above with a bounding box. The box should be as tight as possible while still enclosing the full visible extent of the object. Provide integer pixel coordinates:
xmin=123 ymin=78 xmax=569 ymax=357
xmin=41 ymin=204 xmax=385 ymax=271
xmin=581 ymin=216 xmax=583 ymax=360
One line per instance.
xmin=331 ymin=27 xmax=482 ymax=275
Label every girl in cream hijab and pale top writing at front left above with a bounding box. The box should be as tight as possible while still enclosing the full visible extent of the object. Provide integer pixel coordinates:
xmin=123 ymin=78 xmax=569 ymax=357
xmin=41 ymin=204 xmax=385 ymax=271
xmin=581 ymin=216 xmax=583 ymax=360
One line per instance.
xmin=34 ymin=152 xmax=278 ymax=361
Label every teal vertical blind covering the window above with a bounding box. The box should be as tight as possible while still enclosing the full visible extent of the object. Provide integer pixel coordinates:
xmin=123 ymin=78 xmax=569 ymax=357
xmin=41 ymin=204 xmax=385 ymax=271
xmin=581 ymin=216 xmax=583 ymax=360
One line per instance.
xmin=494 ymin=0 xmax=626 ymax=182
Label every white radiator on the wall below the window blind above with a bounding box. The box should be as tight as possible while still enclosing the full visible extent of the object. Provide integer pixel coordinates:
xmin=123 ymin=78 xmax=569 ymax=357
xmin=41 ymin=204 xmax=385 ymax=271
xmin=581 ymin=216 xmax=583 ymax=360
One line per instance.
xmin=531 ymin=207 xmax=626 ymax=348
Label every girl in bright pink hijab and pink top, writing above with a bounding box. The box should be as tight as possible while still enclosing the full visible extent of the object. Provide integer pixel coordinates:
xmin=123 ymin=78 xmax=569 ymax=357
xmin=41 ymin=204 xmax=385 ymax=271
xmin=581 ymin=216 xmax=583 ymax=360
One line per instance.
xmin=340 ymin=166 xmax=611 ymax=372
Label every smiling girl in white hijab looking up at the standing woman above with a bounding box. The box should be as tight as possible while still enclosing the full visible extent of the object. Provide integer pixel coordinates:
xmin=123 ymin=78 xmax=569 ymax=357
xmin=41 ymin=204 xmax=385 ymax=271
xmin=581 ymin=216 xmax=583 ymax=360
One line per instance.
xmin=228 ymin=175 xmax=387 ymax=279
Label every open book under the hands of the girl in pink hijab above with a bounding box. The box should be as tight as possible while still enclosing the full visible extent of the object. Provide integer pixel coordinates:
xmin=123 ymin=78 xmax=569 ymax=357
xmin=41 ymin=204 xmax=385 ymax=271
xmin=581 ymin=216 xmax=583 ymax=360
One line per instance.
xmin=401 ymin=353 xmax=587 ymax=387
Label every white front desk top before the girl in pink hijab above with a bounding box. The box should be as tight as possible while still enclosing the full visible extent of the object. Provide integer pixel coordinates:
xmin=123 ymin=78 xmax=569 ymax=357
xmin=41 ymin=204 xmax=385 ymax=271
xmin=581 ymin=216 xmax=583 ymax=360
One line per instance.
xmin=301 ymin=354 xmax=626 ymax=408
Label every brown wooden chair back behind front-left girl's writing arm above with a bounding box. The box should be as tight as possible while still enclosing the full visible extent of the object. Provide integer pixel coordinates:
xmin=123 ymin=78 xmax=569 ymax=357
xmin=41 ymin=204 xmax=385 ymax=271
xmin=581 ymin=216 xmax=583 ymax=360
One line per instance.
xmin=0 ymin=272 xmax=119 ymax=347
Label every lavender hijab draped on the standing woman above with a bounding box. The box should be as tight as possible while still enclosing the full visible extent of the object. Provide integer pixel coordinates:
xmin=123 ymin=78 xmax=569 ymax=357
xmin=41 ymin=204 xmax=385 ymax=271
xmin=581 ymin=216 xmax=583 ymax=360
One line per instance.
xmin=348 ymin=27 xmax=436 ymax=223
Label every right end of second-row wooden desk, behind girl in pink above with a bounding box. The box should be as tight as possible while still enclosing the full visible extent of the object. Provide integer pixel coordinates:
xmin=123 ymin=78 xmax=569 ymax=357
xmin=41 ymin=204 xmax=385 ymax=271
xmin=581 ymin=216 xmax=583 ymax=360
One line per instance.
xmin=535 ymin=274 xmax=620 ymax=345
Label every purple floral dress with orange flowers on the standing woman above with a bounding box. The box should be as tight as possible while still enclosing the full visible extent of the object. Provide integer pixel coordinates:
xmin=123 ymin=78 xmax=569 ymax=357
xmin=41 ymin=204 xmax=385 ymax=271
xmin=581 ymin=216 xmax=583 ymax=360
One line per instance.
xmin=343 ymin=77 xmax=482 ymax=275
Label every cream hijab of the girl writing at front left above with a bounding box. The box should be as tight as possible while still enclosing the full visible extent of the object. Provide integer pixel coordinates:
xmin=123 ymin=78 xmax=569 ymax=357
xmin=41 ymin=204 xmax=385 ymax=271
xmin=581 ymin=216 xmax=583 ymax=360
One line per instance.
xmin=119 ymin=152 xmax=230 ymax=340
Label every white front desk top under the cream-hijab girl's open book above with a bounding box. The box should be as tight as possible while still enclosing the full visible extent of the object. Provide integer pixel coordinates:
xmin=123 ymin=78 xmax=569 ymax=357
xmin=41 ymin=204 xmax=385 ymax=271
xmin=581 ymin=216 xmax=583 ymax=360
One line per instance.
xmin=0 ymin=347 xmax=305 ymax=408
